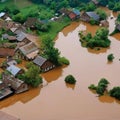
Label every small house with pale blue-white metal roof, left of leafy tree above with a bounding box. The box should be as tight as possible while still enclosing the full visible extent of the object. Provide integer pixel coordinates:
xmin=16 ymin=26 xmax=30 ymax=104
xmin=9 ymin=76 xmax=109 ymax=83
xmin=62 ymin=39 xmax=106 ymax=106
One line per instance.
xmin=6 ymin=65 xmax=23 ymax=76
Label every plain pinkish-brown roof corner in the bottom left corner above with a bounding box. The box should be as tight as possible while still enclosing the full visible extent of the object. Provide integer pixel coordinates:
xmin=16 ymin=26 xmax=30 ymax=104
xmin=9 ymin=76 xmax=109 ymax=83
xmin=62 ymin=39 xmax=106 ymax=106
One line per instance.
xmin=0 ymin=111 xmax=20 ymax=120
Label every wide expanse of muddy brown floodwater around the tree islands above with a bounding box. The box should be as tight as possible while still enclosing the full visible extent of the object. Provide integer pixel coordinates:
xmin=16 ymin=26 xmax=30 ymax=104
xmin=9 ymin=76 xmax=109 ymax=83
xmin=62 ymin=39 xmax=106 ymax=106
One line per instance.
xmin=0 ymin=11 xmax=120 ymax=120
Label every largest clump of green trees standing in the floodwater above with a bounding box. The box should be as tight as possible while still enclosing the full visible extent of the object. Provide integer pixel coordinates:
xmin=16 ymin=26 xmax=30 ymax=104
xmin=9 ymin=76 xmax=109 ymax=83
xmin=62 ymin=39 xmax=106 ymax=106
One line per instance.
xmin=79 ymin=27 xmax=111 ymax=49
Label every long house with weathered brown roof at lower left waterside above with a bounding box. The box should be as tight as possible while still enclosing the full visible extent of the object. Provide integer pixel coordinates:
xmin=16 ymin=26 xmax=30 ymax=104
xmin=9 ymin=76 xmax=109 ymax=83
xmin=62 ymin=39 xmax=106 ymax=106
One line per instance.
xmin=2 ymin=73 xmax=28 ymax=94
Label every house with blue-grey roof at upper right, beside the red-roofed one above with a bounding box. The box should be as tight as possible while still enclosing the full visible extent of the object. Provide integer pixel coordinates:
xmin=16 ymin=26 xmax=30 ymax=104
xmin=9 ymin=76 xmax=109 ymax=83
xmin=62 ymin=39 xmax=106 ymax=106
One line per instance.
xmin=80 ymin=12 xmax=100 ymax=22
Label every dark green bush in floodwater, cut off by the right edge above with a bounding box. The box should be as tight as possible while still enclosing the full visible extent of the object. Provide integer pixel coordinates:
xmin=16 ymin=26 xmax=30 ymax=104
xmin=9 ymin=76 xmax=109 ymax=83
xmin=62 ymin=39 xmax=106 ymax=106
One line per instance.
xmin=109 ymin=87 xmax=120 ymax=100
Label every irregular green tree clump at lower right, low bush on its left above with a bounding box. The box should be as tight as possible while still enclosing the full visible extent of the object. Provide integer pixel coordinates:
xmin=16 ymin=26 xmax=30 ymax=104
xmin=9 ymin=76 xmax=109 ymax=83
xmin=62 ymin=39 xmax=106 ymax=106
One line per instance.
xmin=88 ymin=78 xmax=109 ymax=96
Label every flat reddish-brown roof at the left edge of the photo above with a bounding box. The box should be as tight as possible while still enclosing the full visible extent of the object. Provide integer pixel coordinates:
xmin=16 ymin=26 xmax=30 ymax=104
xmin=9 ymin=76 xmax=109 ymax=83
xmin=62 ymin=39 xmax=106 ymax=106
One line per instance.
xmin=0 ymin=48 xmax=15 ymax=57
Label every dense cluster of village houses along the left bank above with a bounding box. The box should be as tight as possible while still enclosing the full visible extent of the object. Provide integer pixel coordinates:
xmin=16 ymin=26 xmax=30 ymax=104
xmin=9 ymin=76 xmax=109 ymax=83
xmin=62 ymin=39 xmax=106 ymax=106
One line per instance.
xmin=0 ymin=12 xmax=55 ymax=100
